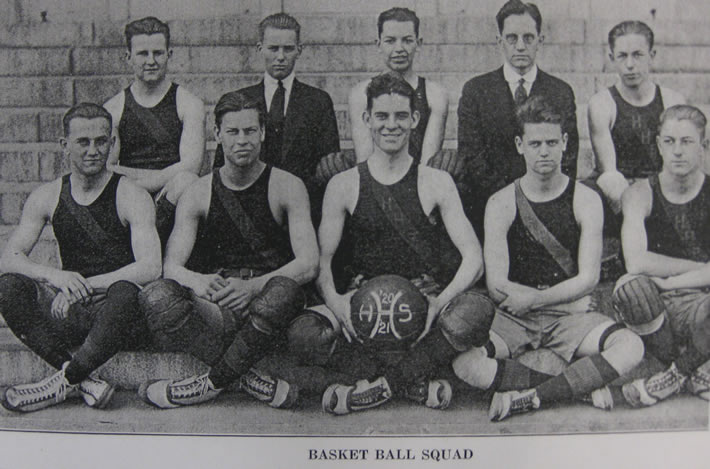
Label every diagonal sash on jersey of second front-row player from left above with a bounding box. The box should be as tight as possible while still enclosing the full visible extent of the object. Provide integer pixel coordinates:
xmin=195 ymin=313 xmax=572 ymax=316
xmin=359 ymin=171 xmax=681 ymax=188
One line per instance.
xmin=212 ymin=169 xmax=288 ymax=270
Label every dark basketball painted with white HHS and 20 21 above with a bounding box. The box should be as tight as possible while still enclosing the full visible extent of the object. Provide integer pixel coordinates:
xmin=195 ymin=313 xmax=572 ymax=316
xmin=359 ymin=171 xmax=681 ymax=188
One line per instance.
xmin=350 ymin=275 xmax=428 ymax=351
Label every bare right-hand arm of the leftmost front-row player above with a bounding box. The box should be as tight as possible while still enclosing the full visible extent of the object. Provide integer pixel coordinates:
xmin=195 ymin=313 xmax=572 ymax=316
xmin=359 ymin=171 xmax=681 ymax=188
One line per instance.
xmin=87 ymin=178 xmax=161 ymax=290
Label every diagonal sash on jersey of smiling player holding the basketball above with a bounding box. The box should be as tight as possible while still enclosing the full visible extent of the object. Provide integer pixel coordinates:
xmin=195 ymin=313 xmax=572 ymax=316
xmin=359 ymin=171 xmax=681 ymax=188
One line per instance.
xmin=360 ymin=166 xmax=441 ymax=277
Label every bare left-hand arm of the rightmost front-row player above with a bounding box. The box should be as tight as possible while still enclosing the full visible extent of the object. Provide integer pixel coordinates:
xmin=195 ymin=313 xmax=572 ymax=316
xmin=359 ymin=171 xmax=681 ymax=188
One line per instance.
xmin=621 ymin=180 xmax=705 ymax=277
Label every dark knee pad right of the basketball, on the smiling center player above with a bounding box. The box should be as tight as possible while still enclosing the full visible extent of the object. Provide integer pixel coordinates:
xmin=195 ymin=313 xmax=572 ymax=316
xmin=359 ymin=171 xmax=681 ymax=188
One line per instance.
xmin=437 ymin=291 xmax=496 ymax=352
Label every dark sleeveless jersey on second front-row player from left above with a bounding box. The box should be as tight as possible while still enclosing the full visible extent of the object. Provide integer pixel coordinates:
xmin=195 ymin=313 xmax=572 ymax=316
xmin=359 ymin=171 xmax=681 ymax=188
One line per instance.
xmin=187 ymin=165 xmax=294 ymax=274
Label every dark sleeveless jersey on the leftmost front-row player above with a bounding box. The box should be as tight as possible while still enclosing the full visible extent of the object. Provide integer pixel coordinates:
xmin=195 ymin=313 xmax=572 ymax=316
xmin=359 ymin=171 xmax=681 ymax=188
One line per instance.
xmin=52 ymin=174 xmax=135 ymax=277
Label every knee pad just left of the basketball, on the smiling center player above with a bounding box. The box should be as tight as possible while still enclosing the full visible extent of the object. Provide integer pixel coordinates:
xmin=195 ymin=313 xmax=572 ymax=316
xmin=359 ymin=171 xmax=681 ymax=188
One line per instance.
xmin=286 ymin=310 xmax=338 ymax=365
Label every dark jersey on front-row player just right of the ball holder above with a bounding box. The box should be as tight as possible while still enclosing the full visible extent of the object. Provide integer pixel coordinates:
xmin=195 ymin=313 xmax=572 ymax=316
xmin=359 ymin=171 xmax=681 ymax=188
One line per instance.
xmin=507 ymin=179 xmax=581 ymax=288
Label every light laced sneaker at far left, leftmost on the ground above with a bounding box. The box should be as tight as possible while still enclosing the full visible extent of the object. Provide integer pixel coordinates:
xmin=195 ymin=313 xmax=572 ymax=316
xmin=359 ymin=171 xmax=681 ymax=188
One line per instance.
xmin=2 ymin=362 xmax=77 ymax=412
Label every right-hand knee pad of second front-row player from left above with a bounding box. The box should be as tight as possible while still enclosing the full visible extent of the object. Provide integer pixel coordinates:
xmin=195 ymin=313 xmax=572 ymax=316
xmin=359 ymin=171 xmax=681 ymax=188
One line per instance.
xmin=249 ymin=277 xmax=306 ymax=335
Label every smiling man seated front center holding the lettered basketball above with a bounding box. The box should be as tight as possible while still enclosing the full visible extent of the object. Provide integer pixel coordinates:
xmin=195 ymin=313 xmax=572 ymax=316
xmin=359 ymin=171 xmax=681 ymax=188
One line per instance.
xmin=246 ymin=74 xmax=493 ymax=414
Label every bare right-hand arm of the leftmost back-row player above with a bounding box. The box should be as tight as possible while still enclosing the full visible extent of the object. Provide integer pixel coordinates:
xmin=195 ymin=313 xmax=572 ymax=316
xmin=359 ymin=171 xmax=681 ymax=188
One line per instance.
xmin=110 ymin=87 xmax=205 ymax=192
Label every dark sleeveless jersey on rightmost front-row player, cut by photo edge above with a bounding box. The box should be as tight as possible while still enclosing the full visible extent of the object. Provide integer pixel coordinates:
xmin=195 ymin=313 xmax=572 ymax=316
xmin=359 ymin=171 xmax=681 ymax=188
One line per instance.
xmin=645 ymin=174 xmax=710 ymax=262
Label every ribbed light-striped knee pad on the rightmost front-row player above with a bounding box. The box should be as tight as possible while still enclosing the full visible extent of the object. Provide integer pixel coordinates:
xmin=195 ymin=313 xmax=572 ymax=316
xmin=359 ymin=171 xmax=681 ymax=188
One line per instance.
xmin=612 ymin=275 xmax=666 ymax=335
